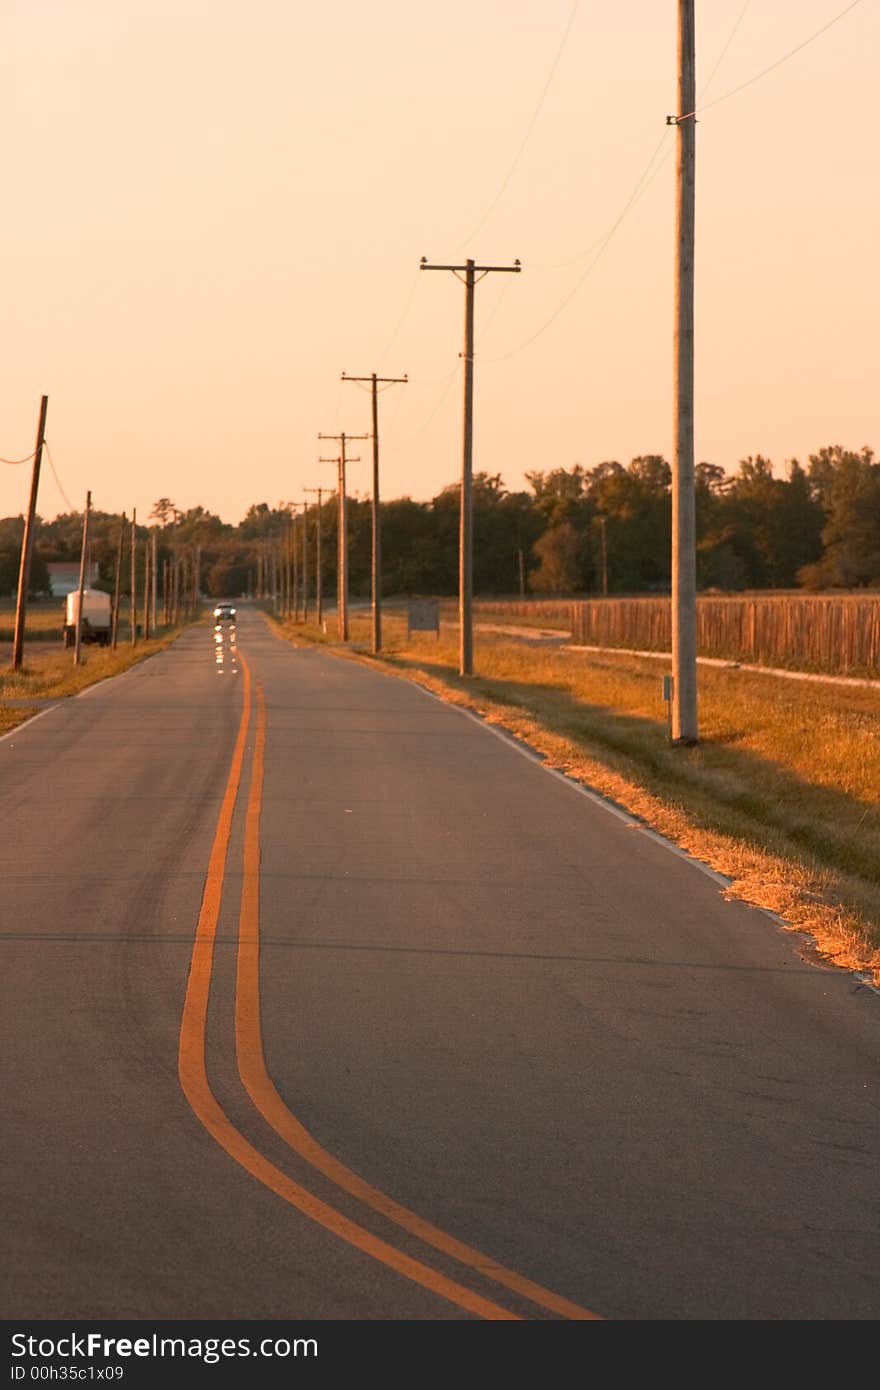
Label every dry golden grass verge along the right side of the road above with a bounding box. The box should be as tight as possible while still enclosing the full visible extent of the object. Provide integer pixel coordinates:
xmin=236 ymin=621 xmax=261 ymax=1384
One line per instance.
xmin=271 ymin=614 xmax=880 ymax=984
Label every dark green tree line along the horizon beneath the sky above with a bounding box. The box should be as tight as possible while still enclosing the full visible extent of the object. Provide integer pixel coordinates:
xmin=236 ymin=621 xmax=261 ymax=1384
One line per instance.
xmin=0 ymin=445 xmax=880 ymax=598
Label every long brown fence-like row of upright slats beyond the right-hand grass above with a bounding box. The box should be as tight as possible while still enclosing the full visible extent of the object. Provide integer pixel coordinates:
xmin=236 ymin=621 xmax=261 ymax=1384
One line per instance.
xmin=570 ymin=594 xmax=880 ymax=676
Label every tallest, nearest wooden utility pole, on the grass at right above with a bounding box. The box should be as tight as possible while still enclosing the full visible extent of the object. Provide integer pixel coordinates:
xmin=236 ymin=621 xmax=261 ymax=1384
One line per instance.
xmin=666 ymin=0 xmax=698 ymax=745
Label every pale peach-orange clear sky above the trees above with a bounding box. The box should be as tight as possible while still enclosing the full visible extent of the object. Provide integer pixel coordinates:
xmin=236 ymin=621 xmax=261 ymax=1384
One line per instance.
xmin=0 ymin=0 xmax=880 ymax=524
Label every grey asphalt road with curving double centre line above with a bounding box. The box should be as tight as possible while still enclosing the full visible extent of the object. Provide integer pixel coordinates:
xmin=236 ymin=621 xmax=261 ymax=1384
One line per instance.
xmin=0 ymin=609 xmax=880 ymax=1321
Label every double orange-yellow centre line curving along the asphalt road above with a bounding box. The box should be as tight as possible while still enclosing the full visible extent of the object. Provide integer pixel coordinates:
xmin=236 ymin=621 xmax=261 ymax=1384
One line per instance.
xmin=178 ymin=652 xmax=599 ymax=1321
